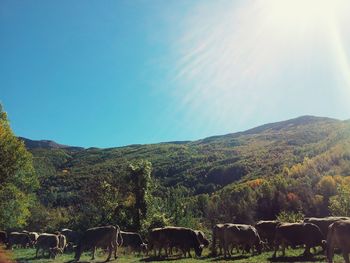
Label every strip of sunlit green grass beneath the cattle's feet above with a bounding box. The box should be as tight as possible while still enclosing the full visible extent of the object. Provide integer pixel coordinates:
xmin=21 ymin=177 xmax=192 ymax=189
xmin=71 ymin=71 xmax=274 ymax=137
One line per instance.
xmin=4 ymin=249 xmax=344 ymax=263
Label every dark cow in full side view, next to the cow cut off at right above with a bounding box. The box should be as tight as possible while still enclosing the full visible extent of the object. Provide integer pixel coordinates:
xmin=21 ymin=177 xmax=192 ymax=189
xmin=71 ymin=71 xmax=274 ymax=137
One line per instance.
xmin=273 ymin=223 xmax=324 ymax=258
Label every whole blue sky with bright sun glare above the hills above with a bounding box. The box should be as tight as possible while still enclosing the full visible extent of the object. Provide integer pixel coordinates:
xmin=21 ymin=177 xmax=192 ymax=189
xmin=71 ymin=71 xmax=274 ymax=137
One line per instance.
xmin=0 ymin=0 xmax=350 ymax=147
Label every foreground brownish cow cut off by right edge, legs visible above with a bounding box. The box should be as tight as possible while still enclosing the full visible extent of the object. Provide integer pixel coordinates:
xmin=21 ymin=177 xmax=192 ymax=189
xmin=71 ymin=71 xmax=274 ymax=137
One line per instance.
xmin=324 ymin=220 xmax=350 ymax=263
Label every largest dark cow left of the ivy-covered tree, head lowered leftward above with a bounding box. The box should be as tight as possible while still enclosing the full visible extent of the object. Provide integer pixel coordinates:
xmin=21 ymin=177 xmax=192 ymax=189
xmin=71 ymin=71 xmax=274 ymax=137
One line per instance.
xmin=75 ymin=226 xmax=120 ymax=261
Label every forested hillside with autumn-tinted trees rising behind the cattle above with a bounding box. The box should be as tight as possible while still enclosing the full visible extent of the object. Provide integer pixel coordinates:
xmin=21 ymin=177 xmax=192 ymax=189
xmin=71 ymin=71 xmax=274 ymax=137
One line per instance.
xmin=15 ymin=116 xmax=350 ymax=234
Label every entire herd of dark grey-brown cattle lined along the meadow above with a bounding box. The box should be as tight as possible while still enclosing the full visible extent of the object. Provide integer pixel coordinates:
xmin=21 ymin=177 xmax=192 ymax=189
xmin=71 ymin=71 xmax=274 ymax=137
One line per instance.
xmin=0 ymin=217 xmax=350 ymax=263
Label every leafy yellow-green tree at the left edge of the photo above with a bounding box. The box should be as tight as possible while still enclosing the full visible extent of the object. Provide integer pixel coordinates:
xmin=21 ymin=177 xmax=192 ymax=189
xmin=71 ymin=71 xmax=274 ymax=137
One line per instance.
xmin=0 ymin=105 xmax=39 ymax=229
